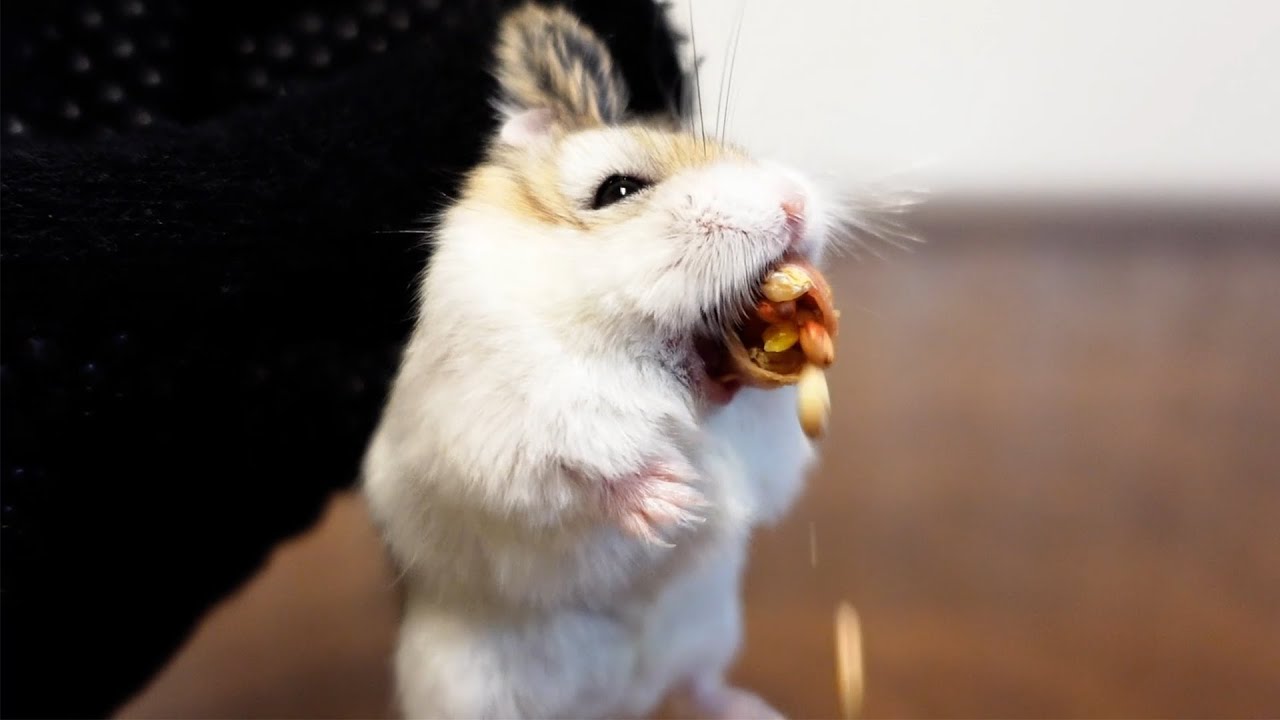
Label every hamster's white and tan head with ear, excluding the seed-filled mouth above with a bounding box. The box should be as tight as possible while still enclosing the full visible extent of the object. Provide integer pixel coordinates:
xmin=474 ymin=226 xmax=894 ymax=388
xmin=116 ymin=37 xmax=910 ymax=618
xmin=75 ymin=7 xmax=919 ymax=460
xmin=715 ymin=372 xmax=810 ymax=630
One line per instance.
xmin=444 ymin=5 xmax=828 ymax=394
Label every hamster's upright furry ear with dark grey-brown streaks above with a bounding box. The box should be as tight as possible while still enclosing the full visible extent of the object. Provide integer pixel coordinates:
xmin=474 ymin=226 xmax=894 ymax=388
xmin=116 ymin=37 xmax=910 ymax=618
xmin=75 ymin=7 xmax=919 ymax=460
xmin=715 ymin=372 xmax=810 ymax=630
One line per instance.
xmin=497 ymin=4 xmax=627 ymax=126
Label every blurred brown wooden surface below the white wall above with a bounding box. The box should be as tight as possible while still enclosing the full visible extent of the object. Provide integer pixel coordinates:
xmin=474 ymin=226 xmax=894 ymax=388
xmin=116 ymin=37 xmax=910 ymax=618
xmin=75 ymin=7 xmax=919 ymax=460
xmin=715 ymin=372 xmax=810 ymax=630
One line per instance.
xmin=120 ymin=203 xmax=1280 ymax=717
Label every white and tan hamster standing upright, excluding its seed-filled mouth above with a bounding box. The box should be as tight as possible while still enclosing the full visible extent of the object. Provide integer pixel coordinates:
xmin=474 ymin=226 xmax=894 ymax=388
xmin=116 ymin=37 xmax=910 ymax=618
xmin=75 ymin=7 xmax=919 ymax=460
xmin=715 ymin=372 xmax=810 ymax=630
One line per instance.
xmin=361 ymin=5 xmax=833 ymax=719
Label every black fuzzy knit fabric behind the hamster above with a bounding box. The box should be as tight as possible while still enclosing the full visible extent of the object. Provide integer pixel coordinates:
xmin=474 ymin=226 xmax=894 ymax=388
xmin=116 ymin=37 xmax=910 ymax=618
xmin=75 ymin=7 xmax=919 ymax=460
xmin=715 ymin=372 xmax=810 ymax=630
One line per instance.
xmin=0 ymin=0 xmax=682 ymax=717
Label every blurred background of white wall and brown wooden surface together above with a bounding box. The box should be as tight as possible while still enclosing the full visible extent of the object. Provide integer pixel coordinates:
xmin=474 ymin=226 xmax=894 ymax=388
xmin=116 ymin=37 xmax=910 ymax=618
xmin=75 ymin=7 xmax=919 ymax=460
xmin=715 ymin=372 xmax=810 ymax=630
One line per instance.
xmin=119 ymin=0 xmax=1280 ymax=717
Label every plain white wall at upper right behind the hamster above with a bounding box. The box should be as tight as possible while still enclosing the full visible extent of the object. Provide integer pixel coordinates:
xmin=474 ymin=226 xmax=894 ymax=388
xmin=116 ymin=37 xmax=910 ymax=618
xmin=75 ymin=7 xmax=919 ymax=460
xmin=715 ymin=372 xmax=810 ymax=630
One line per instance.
xmin=673 ymin=0 xmax=1280 ymax=200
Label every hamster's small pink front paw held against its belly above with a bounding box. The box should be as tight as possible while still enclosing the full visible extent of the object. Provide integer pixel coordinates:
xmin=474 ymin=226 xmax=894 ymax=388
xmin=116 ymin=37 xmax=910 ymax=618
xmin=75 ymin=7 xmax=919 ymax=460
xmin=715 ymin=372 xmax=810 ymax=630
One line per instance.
xmin=604 ymin=462 xmax=708 ymax=547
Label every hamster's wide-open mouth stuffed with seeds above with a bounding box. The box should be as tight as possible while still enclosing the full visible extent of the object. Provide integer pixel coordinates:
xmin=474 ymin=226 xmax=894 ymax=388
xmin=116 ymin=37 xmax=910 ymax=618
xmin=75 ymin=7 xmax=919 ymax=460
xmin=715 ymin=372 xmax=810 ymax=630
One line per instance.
xmin=695 ymin=255 xmax=840 ymax=402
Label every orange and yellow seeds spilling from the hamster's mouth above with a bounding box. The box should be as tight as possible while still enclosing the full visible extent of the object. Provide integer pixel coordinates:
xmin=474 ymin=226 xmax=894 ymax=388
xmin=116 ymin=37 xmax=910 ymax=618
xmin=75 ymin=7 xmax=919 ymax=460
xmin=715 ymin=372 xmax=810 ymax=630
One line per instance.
xmin=712 ymin=259 xmax=840 ymax=438
